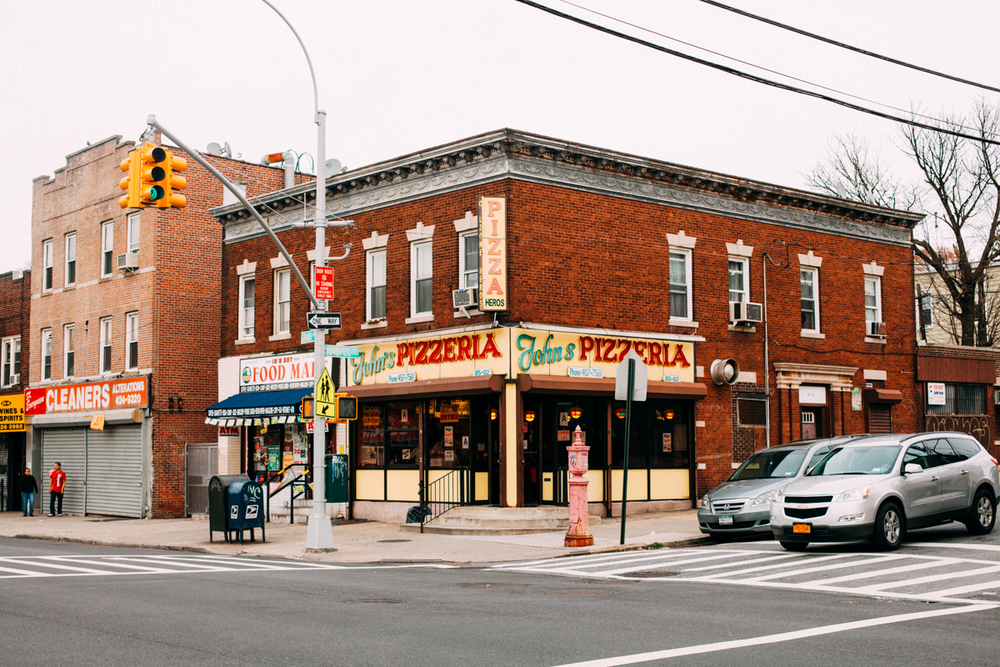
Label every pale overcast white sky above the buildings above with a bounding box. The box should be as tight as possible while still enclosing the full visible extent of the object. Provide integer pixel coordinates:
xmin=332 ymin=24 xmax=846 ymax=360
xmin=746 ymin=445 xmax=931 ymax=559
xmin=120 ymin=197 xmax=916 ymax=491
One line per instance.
xmin=0 ymin=0 xmax=1000 ymax=272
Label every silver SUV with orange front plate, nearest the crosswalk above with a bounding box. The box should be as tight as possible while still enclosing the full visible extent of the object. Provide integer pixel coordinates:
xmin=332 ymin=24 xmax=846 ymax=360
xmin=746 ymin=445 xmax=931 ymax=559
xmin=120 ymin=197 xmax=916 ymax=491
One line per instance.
xmin=771 ymin=433 xmax=1000 ymax=551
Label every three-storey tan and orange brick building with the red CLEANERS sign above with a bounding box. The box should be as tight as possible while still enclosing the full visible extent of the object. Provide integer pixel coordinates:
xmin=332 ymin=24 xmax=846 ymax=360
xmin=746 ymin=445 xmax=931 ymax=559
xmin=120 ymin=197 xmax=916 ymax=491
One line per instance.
xmin=25 ymin=136 xmax=290 ymax=517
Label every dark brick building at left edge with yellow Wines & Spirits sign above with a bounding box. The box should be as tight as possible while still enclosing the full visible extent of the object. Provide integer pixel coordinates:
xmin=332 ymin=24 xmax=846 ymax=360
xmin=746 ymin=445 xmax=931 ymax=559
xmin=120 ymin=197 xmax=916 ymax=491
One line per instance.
xmin=0 ymin=271 xmax=31 ymax=511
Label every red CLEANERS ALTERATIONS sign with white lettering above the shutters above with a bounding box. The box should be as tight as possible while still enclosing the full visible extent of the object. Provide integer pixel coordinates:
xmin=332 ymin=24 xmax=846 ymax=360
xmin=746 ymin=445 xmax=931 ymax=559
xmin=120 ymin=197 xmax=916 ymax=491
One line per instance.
xmin=24 ymin=375 xmax=149 ymax=415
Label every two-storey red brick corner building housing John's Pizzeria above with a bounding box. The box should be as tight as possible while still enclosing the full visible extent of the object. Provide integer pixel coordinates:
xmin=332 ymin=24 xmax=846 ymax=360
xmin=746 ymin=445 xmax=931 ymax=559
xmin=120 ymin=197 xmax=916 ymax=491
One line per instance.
xmin=209 ymin=130 xmax=922 ymax=520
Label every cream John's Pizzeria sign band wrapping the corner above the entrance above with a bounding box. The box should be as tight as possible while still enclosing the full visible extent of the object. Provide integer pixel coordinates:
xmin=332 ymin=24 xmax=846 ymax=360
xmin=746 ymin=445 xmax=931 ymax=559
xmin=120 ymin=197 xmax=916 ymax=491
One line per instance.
xmin=349 ymin=328 xmax=694 ymax=385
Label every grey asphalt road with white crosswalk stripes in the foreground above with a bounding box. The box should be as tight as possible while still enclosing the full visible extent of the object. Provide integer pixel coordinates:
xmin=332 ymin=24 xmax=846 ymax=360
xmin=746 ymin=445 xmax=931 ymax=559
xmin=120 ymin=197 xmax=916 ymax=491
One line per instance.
xmin=0 ymin=527 xmax=1000 ymax=667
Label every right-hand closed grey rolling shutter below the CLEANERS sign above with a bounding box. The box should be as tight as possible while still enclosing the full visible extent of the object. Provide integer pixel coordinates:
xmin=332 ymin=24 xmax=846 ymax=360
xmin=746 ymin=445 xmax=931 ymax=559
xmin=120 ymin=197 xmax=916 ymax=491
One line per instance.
xmin=87 ymin=425 xmax=142 ymax=517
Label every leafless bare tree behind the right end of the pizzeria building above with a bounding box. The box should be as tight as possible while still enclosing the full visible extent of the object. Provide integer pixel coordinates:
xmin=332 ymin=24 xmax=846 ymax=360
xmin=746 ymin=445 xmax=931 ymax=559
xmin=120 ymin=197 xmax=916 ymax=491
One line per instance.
xmin=808 ymin=103 xmax=1000 ymax=346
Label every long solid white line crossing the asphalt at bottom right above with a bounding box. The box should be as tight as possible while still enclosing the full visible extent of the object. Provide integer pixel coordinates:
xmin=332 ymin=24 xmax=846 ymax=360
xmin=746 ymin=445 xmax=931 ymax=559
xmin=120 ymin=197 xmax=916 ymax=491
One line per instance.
xmin=557 ymin=604 xmax=1000 ymax=667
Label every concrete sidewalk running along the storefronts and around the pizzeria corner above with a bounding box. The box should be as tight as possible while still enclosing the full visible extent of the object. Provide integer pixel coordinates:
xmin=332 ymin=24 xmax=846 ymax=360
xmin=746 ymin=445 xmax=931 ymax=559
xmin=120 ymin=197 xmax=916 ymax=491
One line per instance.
xmin=0 ymin=509 xmax=706 ymax=563
